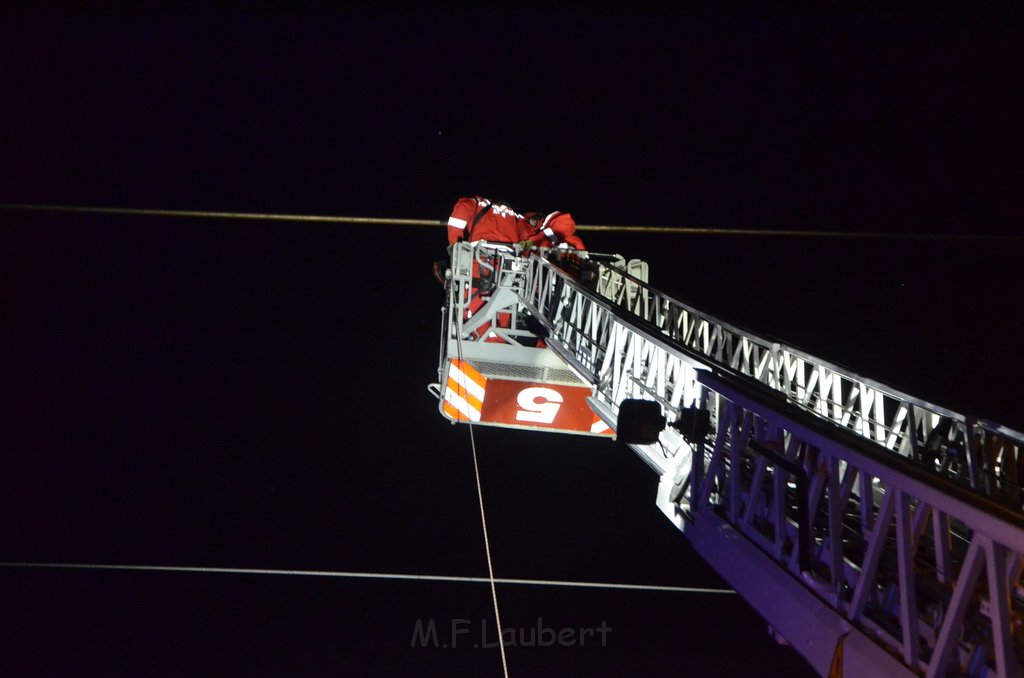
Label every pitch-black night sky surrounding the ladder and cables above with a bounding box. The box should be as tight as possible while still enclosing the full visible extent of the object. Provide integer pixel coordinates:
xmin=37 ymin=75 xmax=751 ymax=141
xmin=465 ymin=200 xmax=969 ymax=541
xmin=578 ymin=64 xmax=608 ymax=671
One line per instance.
xmin=0 ymin=6 xmax=1024 ymax=675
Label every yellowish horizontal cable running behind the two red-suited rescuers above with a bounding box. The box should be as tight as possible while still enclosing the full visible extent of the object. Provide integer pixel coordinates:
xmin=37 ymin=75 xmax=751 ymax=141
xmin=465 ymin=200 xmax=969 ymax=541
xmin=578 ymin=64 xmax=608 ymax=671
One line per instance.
xmin=0 ymin=204 xmax=1024 ymax=242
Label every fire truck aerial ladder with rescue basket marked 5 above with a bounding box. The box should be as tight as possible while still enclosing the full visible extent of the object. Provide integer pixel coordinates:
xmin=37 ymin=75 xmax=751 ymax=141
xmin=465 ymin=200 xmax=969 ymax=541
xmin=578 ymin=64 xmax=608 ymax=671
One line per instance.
xmin=431 ymin=242 xmax=1024 ymax=677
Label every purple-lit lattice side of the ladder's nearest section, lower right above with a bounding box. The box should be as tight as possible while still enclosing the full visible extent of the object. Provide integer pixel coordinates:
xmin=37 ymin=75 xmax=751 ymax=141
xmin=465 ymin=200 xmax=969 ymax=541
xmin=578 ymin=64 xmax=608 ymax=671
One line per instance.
xmin=688 ymin=371 xmax=1024 ymax=676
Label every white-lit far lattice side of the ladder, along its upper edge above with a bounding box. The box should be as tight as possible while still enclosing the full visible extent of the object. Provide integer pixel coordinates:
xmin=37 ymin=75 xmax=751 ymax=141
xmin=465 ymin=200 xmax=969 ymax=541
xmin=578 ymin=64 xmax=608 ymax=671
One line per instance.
xmin=569 ymin=257 xmax=1024 ymax=510
